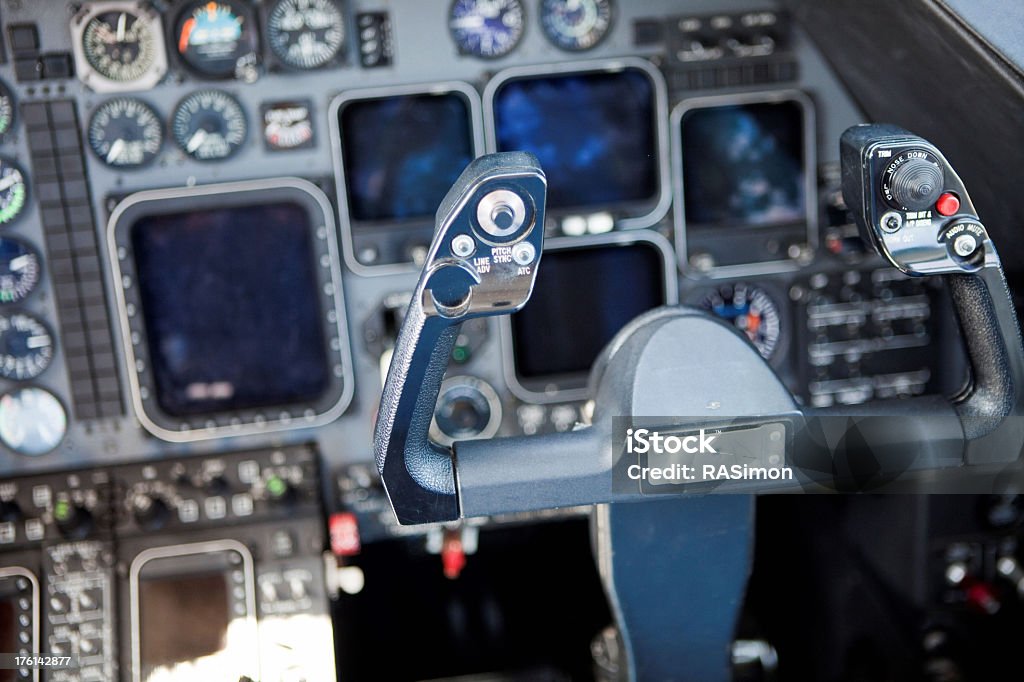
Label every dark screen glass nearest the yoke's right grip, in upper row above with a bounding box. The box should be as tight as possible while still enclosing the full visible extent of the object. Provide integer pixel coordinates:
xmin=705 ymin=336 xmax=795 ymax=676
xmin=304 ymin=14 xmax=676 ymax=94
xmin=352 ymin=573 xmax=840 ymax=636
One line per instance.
xmin=680 ymin=100 xmax=807 ymax=228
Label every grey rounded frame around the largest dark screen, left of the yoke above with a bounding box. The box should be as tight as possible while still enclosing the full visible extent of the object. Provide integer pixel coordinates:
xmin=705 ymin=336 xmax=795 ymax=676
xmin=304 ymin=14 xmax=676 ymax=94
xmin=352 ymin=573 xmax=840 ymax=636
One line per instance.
xmin=106 ymin=177 xmax=353 ymax=442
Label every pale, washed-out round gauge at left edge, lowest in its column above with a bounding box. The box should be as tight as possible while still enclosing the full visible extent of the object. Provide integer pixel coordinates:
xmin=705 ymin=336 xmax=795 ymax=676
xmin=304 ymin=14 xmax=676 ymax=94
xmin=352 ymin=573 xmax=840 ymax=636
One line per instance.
xmin=0 ymin=386 xmax=68 ymax=457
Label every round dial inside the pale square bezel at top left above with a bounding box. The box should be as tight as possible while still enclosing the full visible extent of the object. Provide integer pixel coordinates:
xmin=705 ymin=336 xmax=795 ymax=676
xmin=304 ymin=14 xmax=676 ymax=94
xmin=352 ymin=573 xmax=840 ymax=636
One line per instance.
xmin=82 ymin=9 xmax=162 ymax=83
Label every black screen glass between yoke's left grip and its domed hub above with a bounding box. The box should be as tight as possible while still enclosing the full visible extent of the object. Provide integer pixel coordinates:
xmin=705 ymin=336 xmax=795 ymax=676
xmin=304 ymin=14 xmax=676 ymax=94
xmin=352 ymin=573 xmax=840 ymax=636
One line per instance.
xmin=512 ymin=243 xmax=666 ymax=379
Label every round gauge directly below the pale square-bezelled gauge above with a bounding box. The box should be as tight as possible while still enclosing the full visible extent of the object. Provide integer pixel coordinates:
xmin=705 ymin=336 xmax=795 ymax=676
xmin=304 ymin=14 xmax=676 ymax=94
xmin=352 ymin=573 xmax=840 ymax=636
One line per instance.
xmin=89 ymin=97 xmax=164 ymax=168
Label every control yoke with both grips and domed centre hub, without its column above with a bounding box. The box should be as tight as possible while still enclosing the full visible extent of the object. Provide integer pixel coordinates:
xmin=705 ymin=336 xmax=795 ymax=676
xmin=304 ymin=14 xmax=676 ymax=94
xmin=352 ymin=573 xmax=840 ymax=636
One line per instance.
xmin=374 ymin=125 xmax=1024 ymax=523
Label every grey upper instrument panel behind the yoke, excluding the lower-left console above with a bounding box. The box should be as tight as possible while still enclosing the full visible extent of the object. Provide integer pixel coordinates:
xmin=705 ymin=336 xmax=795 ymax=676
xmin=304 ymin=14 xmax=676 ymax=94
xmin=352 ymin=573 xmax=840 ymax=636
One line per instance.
xmin=0 ymin=0 xmax=962 ymax=472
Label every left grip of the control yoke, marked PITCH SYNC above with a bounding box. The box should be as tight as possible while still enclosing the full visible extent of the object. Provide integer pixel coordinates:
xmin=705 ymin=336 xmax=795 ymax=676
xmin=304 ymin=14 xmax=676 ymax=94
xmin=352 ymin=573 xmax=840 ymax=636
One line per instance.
xmin=374 ymin=152 xmax=547 ymax=523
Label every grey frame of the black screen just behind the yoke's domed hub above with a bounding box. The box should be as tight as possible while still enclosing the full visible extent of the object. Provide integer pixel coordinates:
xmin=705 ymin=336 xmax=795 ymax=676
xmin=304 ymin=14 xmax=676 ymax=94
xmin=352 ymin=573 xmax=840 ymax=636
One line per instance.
xmin=499 ymin=229 xmax=679 ymax=404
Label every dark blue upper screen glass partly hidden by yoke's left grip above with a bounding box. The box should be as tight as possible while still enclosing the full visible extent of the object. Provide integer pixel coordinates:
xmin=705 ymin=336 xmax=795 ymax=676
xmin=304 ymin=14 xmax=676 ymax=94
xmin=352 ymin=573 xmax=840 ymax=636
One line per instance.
xmin=338 ymin=93 xmax=474 ymax=221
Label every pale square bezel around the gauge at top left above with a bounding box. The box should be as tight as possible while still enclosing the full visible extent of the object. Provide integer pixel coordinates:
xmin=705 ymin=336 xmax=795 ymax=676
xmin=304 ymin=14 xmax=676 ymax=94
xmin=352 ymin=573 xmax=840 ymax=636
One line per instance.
xmin=71 ymin=0 xmax=168 ymax=94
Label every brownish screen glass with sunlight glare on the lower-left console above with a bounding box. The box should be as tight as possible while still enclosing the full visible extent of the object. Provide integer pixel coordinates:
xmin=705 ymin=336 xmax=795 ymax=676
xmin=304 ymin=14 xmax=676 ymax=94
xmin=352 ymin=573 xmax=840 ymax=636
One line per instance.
xmin=139 ymin=572 xmax=231 ymax=680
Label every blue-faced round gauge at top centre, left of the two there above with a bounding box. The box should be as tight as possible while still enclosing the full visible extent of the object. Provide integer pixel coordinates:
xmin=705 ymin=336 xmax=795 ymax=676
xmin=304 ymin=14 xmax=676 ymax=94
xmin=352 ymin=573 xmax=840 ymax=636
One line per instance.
xmin=449 ymin=0 xmax=526 ymax=59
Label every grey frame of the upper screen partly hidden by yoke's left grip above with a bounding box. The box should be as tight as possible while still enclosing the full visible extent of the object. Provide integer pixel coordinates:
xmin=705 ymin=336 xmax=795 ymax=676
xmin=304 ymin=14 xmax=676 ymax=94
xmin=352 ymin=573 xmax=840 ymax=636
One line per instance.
xmin=328 ymin=81 xmax=485 ymax=275
